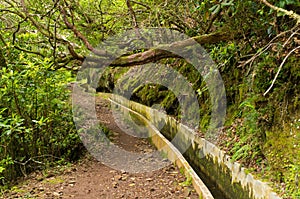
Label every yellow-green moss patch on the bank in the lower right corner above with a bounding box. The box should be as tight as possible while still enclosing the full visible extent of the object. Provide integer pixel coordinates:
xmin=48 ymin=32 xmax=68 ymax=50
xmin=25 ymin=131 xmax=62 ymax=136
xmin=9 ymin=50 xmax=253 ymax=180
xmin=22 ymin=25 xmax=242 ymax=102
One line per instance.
xmin=264 ymin=117 xmax=300 ymax=197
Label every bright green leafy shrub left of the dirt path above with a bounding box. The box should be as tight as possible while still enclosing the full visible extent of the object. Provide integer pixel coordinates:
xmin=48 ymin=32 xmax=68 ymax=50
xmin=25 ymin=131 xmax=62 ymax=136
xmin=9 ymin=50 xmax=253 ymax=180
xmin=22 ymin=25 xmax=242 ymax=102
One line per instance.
xmin=0 ymin=54 xmax=81 ymax=182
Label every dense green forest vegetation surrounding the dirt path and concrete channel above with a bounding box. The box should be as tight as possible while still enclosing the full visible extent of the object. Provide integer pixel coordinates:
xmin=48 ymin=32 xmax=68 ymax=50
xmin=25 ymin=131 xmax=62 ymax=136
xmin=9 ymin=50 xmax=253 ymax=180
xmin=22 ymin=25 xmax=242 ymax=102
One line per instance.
xmin=0 ymin=0 xmax=300 ymax=198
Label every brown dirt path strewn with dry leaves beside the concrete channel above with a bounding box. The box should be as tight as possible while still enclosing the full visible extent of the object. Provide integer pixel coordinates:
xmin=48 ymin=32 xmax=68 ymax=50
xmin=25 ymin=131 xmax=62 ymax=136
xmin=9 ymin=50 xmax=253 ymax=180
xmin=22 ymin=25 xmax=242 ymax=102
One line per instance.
xmin=2 ymin=97 xmax=199 ymax=199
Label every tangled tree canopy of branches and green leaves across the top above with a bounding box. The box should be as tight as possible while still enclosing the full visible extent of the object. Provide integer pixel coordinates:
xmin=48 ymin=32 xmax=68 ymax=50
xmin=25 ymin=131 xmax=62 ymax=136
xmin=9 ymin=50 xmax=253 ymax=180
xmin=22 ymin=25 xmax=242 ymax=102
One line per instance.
xmin=1 ymin=0 xmax=299 ymax=68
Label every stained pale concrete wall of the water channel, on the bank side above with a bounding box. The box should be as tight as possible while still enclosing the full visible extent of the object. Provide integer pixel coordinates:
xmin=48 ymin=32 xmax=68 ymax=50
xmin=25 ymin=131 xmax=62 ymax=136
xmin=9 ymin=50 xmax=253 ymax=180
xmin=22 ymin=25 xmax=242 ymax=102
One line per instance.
xmin=110 ymin=95 xmax=280 ymax=199
